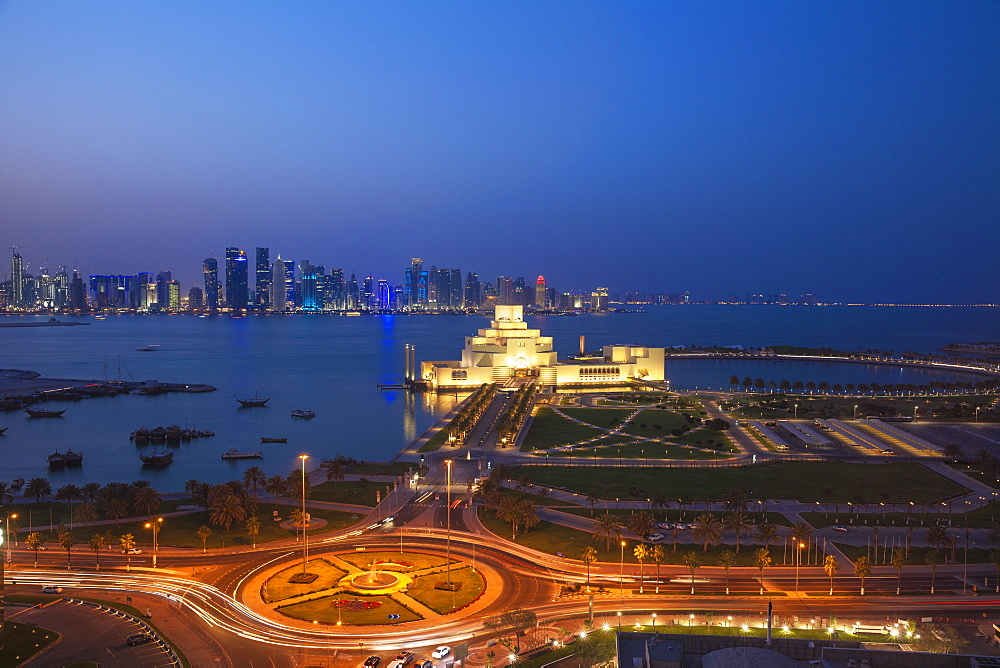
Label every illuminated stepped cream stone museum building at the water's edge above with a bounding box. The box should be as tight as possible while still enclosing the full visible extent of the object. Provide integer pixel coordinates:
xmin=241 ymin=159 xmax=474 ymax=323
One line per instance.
xmin=420 ymin=306 xmax=664 ymax=390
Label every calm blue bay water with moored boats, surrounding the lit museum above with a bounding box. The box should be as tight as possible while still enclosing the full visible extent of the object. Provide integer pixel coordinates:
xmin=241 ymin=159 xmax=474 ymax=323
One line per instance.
xmin=0 ymin=305 xmax=1000 ymax=490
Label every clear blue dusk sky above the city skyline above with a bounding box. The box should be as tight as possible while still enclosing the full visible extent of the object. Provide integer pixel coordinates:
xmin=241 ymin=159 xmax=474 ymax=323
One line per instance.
xmin=0 ymin=0 xmax=1000 ymax=303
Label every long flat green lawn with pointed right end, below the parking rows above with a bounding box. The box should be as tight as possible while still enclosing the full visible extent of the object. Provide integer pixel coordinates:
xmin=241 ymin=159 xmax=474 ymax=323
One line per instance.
xmin=511 ymin=462 xmax=965 ymax=503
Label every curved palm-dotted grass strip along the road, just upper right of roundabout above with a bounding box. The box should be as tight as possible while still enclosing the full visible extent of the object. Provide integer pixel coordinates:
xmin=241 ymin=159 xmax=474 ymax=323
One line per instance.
xmin=479 ymin=508 xmax=796 ymax=577
